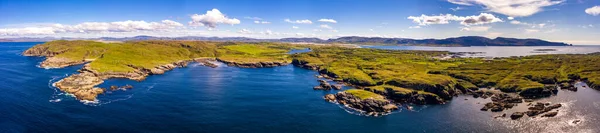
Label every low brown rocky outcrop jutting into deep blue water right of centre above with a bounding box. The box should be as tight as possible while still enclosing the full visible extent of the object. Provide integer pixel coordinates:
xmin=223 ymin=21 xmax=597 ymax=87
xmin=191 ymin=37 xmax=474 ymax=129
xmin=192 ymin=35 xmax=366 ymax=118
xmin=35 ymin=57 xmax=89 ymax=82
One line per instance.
xmin=335 ymin=92 xmax=398 ymax=116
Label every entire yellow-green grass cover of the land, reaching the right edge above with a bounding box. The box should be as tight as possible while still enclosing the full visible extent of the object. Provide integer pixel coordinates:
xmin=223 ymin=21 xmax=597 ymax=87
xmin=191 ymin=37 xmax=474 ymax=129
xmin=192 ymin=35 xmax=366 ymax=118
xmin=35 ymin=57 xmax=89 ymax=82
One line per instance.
xmin=34 ymin=41 xmax=600 ymax=99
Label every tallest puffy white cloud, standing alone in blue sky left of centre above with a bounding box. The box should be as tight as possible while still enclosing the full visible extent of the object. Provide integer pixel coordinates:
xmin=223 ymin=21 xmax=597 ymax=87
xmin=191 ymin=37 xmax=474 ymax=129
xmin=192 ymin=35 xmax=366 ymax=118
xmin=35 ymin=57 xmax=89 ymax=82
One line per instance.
xmin=189 ymin=9 xmax=240 ymax=29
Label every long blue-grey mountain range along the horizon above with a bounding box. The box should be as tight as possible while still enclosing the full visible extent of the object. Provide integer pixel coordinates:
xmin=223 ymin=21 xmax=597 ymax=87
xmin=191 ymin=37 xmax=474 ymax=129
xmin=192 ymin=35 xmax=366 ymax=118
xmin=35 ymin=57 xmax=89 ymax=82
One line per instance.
xmin=0 ymin=36 xmax=571 ymax=46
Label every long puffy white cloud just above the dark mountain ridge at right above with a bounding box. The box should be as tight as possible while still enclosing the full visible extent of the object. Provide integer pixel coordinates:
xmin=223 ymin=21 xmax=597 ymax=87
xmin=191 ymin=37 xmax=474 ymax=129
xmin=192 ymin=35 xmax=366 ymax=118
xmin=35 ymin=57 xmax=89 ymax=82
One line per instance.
xmin=408 ymin=13 xmax=503 ymax=26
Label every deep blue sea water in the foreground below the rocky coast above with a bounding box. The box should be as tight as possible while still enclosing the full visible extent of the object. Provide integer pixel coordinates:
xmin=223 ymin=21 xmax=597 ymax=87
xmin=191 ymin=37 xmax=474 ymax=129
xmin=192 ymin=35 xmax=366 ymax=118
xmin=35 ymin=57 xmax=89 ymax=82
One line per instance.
xmin=0 ymin=42 xmax=600 ymax=133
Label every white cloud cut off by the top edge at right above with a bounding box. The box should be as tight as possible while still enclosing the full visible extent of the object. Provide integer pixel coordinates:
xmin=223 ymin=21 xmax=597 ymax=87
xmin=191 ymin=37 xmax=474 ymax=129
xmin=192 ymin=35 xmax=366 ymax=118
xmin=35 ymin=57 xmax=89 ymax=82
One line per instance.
xmin=448 ymin=0 xmax=565 ymax=17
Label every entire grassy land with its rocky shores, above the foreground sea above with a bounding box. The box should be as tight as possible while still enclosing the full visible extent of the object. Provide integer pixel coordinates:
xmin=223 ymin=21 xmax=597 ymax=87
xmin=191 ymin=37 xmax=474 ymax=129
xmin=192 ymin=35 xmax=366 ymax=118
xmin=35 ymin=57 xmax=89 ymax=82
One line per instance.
xmin=23 ymin=40 xmax=600 ymax=118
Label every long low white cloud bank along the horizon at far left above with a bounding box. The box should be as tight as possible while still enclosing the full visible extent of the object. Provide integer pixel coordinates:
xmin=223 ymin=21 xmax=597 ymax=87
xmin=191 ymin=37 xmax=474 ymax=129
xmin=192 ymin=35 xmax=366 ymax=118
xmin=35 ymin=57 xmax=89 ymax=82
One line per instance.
xmin=0 ymin=20 xmax=183 ymax=36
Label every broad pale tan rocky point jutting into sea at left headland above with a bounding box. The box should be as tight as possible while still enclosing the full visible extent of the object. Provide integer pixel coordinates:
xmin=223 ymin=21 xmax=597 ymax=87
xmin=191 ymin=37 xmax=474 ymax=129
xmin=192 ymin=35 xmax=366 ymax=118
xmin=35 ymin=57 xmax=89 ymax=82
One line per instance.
xmin=53 ymin=72 xmax=104 ymax=101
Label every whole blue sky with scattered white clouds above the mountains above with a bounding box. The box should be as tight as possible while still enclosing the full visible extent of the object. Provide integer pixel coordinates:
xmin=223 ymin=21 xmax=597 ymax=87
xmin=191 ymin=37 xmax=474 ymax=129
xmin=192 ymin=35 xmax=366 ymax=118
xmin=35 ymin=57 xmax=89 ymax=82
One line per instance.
xmin=0 ymin=0 xmax=600 ymax=45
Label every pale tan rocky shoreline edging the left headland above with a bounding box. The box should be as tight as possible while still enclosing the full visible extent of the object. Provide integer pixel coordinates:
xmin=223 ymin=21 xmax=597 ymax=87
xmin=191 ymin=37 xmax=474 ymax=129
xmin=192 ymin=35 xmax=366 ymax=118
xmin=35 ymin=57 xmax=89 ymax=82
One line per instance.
xmin=23 ymin=48 xmax=223 ymax=101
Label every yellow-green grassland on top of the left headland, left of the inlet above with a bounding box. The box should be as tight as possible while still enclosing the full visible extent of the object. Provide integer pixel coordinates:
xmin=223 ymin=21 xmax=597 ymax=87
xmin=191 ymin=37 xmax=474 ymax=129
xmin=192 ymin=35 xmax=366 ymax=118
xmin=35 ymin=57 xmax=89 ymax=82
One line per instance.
xmin=34 ymin=40 xmax=298 ymax=72
